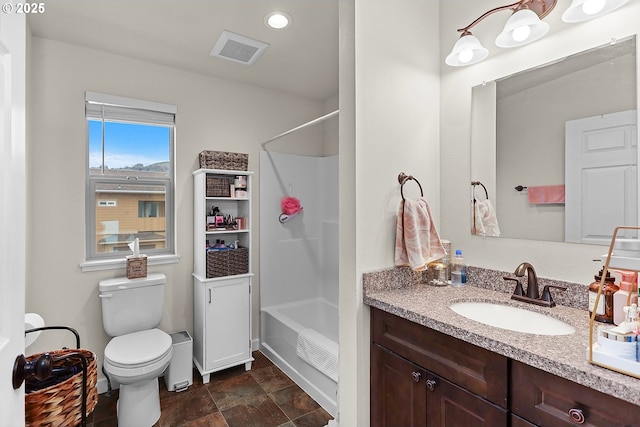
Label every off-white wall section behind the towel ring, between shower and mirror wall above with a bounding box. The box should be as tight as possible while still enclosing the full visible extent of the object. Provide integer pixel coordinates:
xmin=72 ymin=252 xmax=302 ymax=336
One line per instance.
xmin=339 ymin=0 xmax=440 ymax=426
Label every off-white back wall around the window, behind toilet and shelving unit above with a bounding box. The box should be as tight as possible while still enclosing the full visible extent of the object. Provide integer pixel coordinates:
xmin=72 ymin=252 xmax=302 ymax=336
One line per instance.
xmin=26 ymin=37 xmax=324 ymax=382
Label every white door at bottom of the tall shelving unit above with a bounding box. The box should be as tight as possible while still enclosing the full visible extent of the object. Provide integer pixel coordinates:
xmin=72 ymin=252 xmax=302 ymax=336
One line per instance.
xmin=204 ymin=277 xmax=251 ymax=371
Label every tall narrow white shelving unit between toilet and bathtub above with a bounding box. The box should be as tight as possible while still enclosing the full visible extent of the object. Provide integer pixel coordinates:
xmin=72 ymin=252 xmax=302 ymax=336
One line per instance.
xmin=193 ymin=169 xmax=253 ymax=383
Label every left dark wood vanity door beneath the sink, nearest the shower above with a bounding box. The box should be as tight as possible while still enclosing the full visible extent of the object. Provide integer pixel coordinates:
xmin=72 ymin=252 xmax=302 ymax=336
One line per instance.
xmin=371 ymin=344 xmax=427 ymax=427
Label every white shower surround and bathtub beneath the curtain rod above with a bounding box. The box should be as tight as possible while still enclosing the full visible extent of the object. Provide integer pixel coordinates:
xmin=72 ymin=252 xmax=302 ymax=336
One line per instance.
xmin=259 ymin=151 xmax=338 ymax=416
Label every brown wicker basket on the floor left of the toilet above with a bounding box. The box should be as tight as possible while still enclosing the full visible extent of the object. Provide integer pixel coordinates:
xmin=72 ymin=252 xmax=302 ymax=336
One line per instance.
xmin=24 ymin=349 xmax=98 ymax=427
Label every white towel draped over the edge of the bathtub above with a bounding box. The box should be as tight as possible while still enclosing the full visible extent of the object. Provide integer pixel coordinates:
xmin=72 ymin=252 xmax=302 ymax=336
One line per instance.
xmin=296 ymin=329 xmax=338 ymax=382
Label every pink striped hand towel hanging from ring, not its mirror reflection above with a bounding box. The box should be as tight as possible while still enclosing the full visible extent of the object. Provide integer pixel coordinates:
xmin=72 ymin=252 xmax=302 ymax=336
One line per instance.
xmin=395 ymin=198 xmax=446 ymax=271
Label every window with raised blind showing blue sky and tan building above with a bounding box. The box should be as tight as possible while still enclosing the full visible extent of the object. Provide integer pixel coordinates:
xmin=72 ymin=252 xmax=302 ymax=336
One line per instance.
xmin=85 ymin=92 xmax=176 ymax=262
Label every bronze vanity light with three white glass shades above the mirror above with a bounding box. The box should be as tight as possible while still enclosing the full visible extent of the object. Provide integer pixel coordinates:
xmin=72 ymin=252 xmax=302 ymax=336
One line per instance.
xmin=445 ymin=0 xmax=628 ymax=67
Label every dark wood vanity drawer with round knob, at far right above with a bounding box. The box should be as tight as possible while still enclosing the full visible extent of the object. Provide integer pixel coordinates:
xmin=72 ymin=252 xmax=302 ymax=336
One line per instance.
xmin=511 ymin=360 xmax=640 ymax=427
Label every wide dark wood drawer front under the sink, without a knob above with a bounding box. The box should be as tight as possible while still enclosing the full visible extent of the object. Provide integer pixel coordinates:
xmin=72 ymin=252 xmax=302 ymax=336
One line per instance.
xmin=371 ymin=308 xmax=508 ymax=408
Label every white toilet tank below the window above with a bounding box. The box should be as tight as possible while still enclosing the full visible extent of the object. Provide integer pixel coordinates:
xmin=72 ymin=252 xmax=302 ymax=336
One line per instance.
xmin=98 ymin=273 xmax=166 ymax=337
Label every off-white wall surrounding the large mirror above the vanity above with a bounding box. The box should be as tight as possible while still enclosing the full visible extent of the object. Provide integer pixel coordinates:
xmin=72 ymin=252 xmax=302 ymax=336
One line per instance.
xmin=440 ymin=0 xmax=640 ymax=285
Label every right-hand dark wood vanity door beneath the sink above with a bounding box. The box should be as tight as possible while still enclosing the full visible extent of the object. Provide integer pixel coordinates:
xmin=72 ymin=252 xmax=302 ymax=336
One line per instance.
xmin=426 ymin=372 xmax=508 ymax=427
